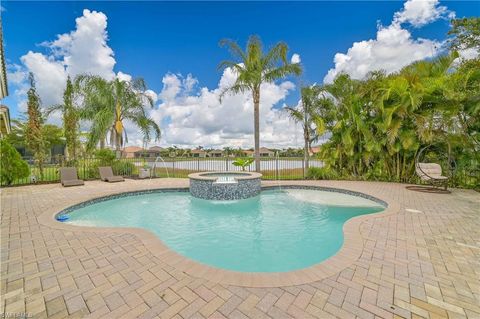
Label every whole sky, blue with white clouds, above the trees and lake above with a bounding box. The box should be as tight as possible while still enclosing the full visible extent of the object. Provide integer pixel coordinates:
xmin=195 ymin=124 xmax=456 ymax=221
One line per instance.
xmin=0 ymin=0 xmax=480 ymax=148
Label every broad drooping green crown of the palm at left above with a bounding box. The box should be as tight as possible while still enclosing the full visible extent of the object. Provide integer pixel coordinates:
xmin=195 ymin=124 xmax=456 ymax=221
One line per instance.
xmin=75 ymin=75 xmax=161 ymax=155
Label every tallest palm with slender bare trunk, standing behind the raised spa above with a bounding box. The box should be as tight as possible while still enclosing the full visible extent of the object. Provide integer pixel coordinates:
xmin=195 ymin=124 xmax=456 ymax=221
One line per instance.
xmin=219 ymin=36 xmax=302 ymax=172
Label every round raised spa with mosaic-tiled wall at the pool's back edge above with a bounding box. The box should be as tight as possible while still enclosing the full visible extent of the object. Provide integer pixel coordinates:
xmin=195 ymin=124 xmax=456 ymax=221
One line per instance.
xmin=188 ymin=172 xmax=262 ymax=200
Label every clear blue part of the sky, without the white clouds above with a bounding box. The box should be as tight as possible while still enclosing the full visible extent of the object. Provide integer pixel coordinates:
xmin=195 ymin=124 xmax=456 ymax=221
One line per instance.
xmin=2 ymin=0 xmax=480 ymax=148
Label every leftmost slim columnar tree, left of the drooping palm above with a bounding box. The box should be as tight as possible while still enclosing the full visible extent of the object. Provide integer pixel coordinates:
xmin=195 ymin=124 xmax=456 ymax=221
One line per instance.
xmin=25 ymin=73 xmax=46 ymax=180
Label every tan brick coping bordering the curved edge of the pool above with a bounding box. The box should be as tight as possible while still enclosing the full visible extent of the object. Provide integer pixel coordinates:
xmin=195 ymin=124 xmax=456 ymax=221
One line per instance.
xmin=38 ymin=183 xmax=400 ymax=288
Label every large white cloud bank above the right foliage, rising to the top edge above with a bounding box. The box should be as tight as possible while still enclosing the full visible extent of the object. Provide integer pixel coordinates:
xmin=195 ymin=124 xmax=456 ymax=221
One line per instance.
xmin=324 ymin=0 xmax=454 ymax=83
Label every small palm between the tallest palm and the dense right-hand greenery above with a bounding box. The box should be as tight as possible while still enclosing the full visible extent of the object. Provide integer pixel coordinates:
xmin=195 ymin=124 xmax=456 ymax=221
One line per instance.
xmin=284 ymin=86 xmax=329 ymax=173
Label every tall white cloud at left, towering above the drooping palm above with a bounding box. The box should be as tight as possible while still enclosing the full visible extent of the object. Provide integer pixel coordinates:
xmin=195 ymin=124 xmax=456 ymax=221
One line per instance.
xmin=14 ymin=9 xmax=116 ymax=106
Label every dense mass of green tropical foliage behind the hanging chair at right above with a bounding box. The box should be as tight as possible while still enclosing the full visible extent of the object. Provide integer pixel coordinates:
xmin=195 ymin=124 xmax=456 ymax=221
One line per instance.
xmin=320 ymin=44 xmax=480 ymax=185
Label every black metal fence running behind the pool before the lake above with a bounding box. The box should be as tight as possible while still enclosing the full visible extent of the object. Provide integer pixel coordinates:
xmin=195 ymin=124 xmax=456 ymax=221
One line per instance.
xmin=2 ymin=157 xmax=323 ymax=185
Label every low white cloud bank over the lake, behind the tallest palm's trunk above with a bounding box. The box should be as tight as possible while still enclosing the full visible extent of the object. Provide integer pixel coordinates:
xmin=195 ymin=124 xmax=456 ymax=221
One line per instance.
xmin=139 ymin=69 xmax=302 ymax=147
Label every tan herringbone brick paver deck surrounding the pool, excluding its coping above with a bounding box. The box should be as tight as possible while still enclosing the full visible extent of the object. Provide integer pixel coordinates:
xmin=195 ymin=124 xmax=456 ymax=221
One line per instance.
xmin=0 ymin=179 xmax=480 ymax=318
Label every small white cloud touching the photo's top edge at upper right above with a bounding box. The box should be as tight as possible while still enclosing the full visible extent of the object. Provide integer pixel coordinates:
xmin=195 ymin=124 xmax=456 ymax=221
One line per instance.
xmin=394 ymin=0 xmax=455 ymax=27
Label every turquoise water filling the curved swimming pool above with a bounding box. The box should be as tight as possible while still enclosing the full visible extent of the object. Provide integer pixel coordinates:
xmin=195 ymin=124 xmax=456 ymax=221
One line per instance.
xmin=66 ymin=189 xmax=384 ymax=272
